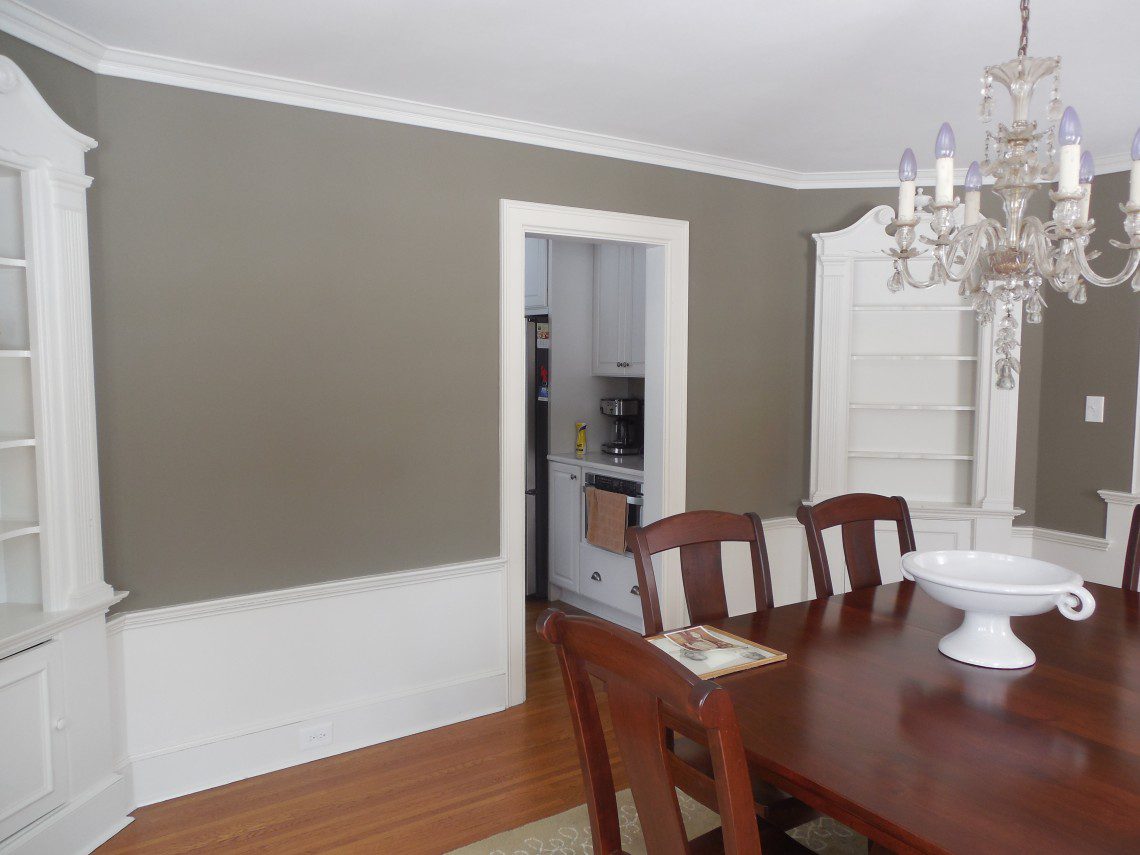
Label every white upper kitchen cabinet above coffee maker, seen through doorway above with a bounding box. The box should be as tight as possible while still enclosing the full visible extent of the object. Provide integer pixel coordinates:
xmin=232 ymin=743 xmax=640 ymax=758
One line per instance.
xmin=594 ymin=244 xmax=645 ymax=377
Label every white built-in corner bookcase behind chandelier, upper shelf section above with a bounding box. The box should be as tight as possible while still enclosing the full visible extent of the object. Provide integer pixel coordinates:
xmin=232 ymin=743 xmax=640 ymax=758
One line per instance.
xmin=809 ymin=205 xmax=1020 ymax=592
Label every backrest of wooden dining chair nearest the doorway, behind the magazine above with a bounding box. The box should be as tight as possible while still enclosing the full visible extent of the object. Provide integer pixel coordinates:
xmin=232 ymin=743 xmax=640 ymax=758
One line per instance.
xmin=626 ymin=511 xmax=773 ymax=635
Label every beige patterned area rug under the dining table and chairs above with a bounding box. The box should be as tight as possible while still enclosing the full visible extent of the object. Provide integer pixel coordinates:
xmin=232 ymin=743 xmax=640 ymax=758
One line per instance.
xmin=448 ymin=790 xmax=866 ymax=855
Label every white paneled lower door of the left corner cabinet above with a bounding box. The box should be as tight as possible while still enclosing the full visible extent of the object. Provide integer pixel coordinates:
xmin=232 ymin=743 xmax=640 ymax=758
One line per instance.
xmin=0 ymin=642 xmax=67 ymax=840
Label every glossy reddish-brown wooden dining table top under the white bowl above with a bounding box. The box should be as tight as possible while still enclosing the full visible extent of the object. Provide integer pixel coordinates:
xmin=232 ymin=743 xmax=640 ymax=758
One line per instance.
xmin=713 ymin=581 xmax=1140 ymax=855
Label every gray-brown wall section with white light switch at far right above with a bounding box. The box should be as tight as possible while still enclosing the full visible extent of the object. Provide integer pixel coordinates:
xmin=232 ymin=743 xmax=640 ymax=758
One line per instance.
xmin=1035 ymin=172 xmax=1140 ymax=537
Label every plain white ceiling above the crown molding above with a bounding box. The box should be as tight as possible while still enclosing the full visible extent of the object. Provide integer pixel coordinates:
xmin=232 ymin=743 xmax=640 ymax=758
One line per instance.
xmin=0 ymin=0 xmax=1140 ymax=182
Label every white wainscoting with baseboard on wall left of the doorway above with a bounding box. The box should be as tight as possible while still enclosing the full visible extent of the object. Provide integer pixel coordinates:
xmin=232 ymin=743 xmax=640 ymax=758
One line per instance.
xmin=108 ymin=559 xmax=507 ymax=805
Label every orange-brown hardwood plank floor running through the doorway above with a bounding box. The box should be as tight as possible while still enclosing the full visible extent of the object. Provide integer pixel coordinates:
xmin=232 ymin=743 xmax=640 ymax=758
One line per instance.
xmin=97 ymin=603 xmax=626 ymax=855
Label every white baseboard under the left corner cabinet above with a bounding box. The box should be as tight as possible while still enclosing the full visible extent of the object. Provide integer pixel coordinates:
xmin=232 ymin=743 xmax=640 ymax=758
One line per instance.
xmin=0 ymin=774 xmax=133 ymax=855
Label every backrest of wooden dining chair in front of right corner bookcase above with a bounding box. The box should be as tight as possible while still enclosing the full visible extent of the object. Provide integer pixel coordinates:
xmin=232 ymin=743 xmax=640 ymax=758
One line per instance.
xmin=796 ymin=492 xmax=915 ymax=597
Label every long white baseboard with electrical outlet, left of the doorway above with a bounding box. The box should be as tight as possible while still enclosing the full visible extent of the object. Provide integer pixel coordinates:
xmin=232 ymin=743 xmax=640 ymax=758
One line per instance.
xmin=128 ymin=671 xmax=506 ymax=807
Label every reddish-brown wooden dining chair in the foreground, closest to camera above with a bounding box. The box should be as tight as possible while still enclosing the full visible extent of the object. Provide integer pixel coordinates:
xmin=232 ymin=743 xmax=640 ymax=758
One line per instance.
xmin=538 ymin=609 xmax=808 ymax=855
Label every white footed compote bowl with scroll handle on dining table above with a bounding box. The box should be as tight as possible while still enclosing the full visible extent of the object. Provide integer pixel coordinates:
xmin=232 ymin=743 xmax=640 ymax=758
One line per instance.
xmin=903 ymin=549 xmax=1097 ymax=668
